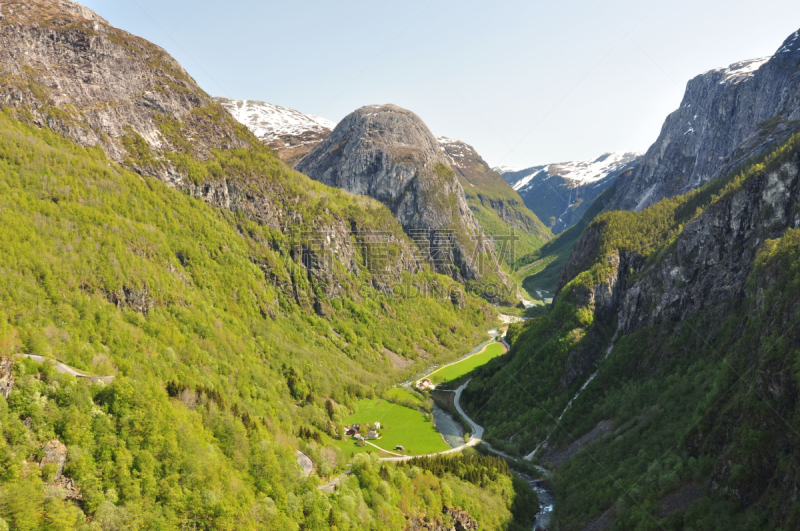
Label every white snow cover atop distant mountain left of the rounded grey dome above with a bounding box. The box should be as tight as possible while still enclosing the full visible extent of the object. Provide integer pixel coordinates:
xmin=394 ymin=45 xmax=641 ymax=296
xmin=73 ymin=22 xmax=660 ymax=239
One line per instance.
xmin=219 ymin=98 xmax=336 ymax=143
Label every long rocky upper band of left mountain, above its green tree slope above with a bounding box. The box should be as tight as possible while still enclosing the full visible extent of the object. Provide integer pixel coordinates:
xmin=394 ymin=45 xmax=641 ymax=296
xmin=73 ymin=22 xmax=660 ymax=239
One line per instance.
xmin=0 ymin=0 xmax=438 ymax=311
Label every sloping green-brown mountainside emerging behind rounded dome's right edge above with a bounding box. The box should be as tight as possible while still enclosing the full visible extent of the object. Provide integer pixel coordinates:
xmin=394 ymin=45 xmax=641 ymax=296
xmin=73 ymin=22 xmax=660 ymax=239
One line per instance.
xmin=438 ymin=137 xmax=550 ymax=240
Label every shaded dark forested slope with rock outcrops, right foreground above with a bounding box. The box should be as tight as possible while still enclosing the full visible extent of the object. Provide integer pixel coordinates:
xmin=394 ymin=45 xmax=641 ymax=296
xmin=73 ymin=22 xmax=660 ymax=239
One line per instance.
xmin=465 ymin=124 xmax=800 ymax=529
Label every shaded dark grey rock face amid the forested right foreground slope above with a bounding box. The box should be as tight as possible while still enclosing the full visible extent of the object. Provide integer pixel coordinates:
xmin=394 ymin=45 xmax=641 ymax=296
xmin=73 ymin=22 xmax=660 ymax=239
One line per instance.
xmin=619 ymin=156 xmax=800 ymax=333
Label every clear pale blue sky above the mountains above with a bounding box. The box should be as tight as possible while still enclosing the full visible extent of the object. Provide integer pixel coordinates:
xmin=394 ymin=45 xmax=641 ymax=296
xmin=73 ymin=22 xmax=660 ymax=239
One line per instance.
xmin=83 ymin=0 xmax=800 ymax=167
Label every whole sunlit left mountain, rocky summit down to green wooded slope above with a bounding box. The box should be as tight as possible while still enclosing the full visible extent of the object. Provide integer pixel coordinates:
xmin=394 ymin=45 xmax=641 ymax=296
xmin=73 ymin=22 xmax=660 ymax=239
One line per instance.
xmin=0 ymin=0 xmax=536 ymax=530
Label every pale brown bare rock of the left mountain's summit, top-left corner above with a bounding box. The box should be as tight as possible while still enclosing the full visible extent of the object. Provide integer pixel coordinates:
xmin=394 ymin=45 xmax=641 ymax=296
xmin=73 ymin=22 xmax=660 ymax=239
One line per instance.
xmin=0 ymin=0 xmax=248 ymax=175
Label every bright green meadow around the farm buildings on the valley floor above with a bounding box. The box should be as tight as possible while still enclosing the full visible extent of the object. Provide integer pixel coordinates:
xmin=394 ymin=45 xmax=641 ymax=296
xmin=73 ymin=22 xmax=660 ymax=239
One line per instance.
xmin=336 ymin=400 xmax=450 ymax=455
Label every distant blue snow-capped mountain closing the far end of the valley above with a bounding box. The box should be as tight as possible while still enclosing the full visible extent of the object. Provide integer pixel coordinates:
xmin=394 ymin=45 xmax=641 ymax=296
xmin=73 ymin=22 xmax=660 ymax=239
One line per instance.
xmin=503 ymin=152 xmax=641 ymax=234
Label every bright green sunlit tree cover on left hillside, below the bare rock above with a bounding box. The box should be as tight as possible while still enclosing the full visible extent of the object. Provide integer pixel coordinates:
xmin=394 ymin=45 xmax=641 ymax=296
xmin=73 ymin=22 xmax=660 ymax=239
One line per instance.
xmin=0 ymin=112 xmax=544 ymax=530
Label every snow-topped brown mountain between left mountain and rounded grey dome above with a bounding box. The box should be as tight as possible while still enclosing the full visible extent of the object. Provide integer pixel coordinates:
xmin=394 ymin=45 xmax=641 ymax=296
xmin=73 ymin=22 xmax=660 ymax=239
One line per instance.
xmin=217 ymin=98 xmax=336 ymax=164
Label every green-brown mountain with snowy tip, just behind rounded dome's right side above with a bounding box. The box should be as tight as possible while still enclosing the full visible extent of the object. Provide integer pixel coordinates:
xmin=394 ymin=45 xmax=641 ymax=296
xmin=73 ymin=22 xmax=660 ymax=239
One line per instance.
xmin=438 ymin=137 xmax=552 ymax=264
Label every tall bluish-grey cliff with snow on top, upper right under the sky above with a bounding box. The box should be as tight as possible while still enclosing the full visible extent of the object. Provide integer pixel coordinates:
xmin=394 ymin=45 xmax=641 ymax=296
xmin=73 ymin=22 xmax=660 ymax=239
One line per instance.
xmin=609 ymin=31 xmax=800 ymax=210
